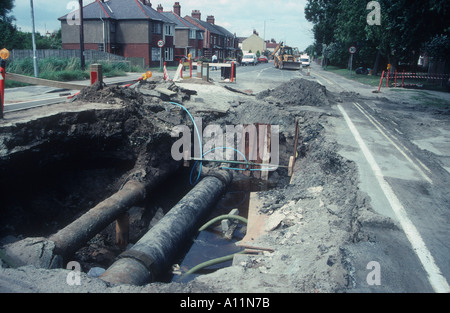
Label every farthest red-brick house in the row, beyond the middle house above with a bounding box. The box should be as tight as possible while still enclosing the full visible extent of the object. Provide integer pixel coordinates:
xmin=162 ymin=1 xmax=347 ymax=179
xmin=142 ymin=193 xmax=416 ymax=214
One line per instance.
xmin=184 ymin=10 xmax=238 ymax=59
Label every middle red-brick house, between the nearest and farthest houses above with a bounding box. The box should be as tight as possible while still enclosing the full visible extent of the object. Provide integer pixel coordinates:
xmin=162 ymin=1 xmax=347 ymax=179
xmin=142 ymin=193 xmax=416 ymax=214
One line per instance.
xmin=157 ymin=2 xmax=204 ymax=59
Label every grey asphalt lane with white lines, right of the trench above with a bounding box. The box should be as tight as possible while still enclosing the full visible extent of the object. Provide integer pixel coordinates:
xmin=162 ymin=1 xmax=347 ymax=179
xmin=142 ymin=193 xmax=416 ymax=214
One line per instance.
xmin=312 ymin=62 xmax=450 ymax=292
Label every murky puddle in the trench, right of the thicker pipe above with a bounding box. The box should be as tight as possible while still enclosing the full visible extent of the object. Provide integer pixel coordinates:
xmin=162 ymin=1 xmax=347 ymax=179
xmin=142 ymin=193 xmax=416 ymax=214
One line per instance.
xmin=166 ymin=177 xmax=276 ymax=282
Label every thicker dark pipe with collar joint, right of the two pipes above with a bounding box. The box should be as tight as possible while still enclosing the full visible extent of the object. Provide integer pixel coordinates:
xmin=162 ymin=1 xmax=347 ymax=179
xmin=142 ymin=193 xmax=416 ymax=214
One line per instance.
xmin=100 ymin=170 xmax=232 ymax=285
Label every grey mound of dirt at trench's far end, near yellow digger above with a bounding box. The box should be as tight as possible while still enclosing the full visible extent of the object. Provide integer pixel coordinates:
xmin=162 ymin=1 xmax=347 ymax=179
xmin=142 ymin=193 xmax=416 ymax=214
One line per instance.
xmin=256 ymin=79 xmax=332 ymax=107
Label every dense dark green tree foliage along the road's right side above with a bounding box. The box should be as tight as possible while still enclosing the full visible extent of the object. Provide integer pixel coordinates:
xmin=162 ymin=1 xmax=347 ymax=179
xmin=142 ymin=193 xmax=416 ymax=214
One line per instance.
xmin=305 ymin=0 xmax=450 ymax=72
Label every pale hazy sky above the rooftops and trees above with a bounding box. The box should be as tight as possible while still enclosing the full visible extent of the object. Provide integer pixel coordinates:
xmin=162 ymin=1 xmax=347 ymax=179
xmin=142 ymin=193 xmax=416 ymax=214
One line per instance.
xmin=12 ymin=0 xmax=314 ymax=50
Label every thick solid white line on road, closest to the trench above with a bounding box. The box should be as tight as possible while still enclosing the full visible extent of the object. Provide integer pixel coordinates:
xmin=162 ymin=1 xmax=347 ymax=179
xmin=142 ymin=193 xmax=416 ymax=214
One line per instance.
xmin=337 ymin=105 xmax=450 ymax=293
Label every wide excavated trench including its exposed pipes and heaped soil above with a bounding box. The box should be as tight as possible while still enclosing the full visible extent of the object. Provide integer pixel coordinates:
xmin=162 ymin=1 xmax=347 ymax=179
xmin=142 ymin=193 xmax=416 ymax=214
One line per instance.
xmin=0 ymin=81 xmax=366 ymax=292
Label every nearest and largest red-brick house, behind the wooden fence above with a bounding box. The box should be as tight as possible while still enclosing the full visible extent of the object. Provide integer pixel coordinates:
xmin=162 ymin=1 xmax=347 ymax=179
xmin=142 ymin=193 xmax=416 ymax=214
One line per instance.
xmin=59 ymin=0 xmax=175 ymax=66
